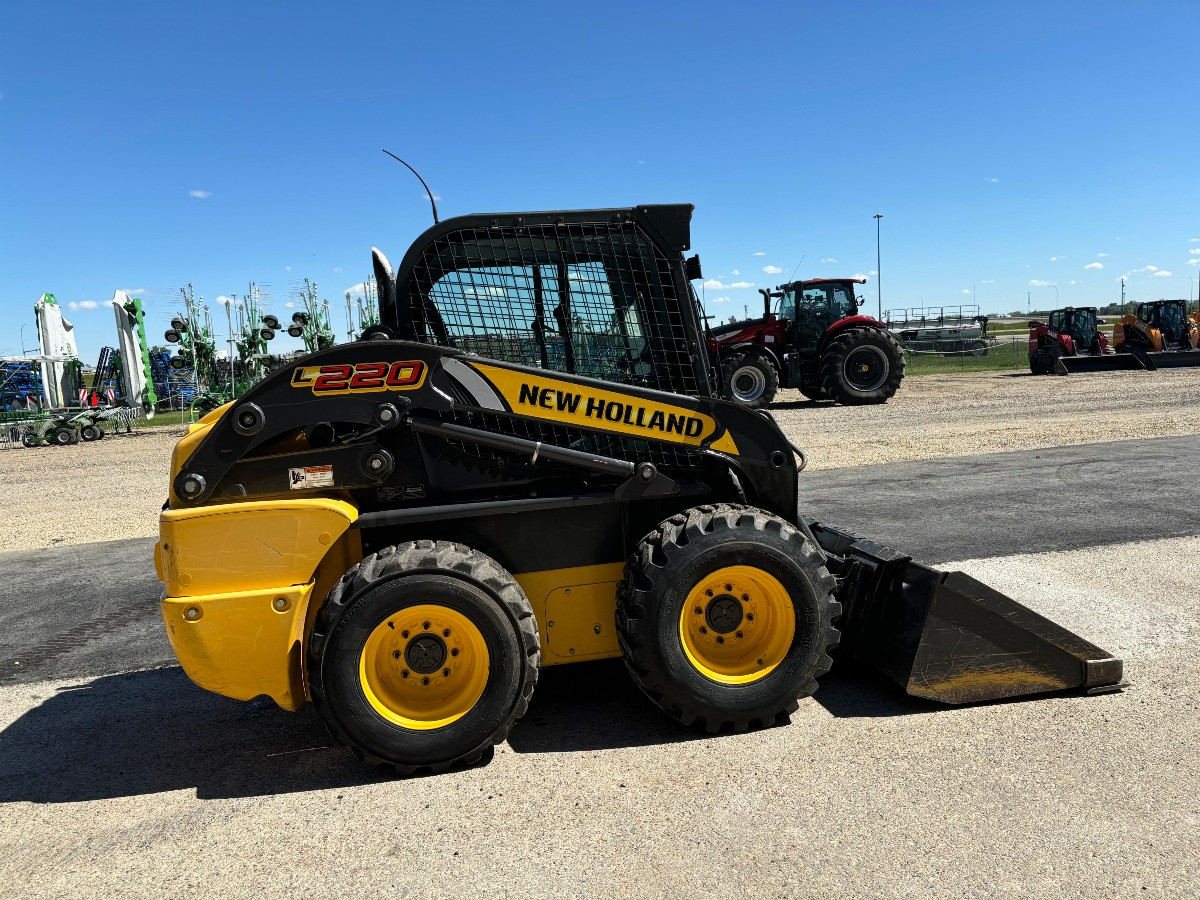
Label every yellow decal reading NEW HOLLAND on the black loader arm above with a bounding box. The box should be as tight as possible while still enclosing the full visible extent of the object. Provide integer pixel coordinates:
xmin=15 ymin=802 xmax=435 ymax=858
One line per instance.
xmin=469 ymin=361 xmax=737 ymax=454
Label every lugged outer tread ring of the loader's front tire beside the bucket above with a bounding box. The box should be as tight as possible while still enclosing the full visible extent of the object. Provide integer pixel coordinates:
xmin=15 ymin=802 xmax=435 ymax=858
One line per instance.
xmin=617 ymin=503 xmax=841 ymax=734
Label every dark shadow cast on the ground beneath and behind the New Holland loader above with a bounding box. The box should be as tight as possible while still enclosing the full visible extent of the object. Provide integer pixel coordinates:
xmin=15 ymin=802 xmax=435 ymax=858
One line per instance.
xmin=0 ymin=660 xmax=937 ymax=803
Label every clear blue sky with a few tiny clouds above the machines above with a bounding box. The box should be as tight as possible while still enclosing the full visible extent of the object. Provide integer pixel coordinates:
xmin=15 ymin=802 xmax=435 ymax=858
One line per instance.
xmin=0 ymin=0 xmax=1200 ymax=362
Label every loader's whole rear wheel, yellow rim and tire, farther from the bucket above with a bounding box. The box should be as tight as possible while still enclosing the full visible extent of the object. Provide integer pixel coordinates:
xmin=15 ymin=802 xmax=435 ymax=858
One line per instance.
xmin=307 ymin=540 xmax=541 ymax=775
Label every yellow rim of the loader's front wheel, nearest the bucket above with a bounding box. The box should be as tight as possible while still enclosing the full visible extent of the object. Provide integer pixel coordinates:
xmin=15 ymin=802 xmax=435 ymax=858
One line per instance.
xmin=679 ymin=565 xmax=796 ymax=684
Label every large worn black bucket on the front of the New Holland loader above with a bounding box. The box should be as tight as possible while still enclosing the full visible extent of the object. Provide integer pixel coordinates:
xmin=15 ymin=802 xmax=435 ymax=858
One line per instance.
xmin=804 ymin=520 xmax=1123 ymax=703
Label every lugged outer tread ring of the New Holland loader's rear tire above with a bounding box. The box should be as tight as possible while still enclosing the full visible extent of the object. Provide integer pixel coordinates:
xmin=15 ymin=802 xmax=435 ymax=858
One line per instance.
xmin=307 ymin=540 xmax=541 ymax=775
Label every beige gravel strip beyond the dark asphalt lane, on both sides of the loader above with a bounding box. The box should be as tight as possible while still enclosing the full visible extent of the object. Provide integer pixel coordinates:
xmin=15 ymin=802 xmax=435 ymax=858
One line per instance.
xmin=0 ymin=370 xmax=1200 ymax=551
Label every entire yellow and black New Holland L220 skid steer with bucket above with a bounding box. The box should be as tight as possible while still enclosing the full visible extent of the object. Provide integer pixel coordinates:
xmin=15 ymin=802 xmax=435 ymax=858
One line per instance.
xmin=155 ymin=205 xmax=1122 ymax=773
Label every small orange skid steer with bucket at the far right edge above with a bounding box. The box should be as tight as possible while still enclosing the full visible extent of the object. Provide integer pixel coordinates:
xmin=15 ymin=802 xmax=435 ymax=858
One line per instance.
xmin=1060 ymin=300 xmax=1200 ymax=374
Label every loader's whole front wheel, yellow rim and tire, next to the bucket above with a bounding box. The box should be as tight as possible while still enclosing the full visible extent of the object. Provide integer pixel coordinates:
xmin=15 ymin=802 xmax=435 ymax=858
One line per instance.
xmin=617 ymin=504 xmax=841 ymax=733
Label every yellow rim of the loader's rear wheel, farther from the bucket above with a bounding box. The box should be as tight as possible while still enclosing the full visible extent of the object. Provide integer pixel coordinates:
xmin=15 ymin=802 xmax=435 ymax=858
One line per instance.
xmin=359 ymin=604 xmax=490 ymax=731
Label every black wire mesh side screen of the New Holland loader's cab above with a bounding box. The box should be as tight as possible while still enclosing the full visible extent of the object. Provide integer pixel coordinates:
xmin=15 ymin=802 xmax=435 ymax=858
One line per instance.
xmin=397 ymin=222 xmax=697 ymax=395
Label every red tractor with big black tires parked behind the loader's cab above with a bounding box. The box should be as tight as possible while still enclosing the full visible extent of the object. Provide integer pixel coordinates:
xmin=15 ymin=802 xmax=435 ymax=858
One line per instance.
xmin=709 ymin=278 xmax=905 ymax=408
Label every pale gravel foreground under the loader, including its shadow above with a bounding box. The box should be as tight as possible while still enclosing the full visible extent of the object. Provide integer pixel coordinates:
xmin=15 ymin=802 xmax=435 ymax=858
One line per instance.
xmin=0 ymin=538 xmax=1200 ymax=899
